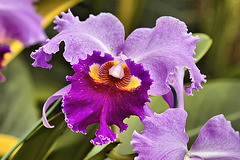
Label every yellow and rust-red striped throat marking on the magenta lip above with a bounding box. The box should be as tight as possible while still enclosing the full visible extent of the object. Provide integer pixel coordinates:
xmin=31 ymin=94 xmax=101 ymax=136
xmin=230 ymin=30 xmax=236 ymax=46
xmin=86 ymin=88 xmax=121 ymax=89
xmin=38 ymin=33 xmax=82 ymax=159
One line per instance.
xmin=89 ymin=61 xmax=141 ymax=91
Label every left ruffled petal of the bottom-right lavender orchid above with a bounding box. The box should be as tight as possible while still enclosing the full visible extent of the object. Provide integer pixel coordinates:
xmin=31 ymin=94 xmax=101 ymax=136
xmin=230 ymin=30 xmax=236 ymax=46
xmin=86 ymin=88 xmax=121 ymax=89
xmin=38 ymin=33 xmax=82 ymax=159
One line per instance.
xmin=131 ymin=108 xmax=188 ymax=160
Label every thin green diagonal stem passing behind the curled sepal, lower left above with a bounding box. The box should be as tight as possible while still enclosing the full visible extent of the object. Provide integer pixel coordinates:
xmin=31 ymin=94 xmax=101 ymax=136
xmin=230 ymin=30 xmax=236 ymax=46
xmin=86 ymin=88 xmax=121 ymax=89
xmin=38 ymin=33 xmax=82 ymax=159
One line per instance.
xmin=1 ymin=99 xmax=62 ymax=160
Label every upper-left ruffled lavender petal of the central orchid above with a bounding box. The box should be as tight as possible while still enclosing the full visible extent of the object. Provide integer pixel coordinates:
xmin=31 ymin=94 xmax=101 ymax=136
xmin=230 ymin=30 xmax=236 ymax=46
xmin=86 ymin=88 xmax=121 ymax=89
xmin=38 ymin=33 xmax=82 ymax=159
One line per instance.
xmin=32 ymin=10 xmax=124 ymax=68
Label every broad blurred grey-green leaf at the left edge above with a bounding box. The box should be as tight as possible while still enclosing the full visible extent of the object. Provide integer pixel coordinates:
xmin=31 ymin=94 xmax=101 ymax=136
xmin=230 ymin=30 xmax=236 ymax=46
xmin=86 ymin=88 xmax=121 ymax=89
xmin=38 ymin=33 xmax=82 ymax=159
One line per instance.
xmin=0 ymin=57 xmax=38 ymax=137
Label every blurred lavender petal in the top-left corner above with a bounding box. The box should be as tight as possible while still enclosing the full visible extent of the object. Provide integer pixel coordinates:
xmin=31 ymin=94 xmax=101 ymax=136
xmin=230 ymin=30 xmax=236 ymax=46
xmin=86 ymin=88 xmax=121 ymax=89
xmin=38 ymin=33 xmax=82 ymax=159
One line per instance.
xmin=0 ymin=0 xmax=46 ymax=46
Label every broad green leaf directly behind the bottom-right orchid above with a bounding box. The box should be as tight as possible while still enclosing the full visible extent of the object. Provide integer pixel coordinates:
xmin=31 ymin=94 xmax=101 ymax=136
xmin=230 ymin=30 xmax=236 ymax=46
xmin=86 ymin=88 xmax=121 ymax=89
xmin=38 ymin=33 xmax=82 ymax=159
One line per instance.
xmin=185 ymin=79 xmax=240 ymax=145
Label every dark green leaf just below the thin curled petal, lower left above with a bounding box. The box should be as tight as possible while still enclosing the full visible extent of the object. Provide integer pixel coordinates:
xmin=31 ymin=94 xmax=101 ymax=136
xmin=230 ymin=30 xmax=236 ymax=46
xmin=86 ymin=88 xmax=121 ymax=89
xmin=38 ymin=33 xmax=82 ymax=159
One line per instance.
xmin=13 ymin=113 xmax=67 ymax=160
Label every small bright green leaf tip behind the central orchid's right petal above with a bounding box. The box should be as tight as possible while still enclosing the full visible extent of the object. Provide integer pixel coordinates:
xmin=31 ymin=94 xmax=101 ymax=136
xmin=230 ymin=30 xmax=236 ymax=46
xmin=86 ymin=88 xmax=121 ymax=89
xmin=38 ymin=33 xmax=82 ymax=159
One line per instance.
xmin=193 ymin=33 xmax=212 ymax=63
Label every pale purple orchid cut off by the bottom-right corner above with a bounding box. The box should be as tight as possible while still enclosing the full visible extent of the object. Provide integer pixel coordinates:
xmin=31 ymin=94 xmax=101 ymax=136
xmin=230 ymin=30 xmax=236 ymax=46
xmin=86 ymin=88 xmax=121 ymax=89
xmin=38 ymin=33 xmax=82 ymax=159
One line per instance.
xmin=131 ymin=108 xmax=240 ymax=160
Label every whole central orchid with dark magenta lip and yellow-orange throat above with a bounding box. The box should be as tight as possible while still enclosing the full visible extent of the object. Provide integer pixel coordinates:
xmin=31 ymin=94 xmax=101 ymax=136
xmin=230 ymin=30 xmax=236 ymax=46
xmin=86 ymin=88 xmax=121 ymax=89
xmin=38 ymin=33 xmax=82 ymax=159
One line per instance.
xmin=31 ymin=10 xmax=206 ymax=144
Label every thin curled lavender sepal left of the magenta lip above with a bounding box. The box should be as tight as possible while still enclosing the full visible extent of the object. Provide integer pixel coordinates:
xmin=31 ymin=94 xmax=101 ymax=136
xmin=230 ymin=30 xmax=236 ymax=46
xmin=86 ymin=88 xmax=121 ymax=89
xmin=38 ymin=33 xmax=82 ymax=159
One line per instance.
xmin=42 ymin=85 xmax=71 ymax=128
